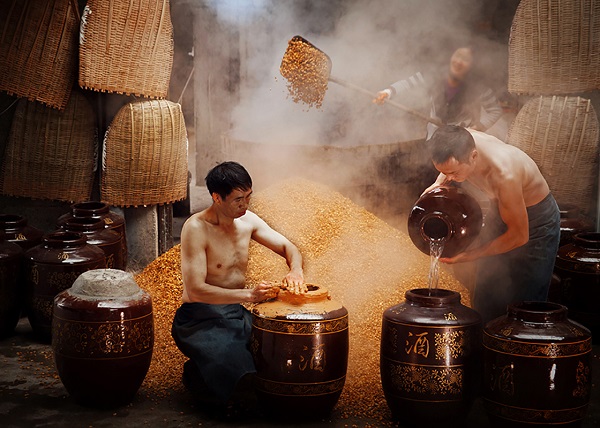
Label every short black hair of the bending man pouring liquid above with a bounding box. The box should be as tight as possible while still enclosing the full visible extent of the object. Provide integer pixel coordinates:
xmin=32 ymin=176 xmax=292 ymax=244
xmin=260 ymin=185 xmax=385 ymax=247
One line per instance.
xmin=428 ymin=125 xmax=475 ymax=164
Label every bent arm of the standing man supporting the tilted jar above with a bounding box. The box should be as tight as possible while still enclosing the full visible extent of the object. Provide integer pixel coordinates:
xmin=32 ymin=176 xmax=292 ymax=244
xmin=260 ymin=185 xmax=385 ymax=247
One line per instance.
xmin=440 ymin=179 xmax=529 ymax=263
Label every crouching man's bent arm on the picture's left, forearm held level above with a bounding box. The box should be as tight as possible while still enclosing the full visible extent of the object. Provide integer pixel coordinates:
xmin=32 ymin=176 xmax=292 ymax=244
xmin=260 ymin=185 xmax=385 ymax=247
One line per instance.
xmin=181 ymin=218 xmax=277 ymax=304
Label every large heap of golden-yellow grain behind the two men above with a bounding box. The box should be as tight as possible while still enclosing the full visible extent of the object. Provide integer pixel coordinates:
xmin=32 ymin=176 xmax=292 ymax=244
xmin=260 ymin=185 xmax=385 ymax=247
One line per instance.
xmin=136 ymin=179 xmax=469 ymax=422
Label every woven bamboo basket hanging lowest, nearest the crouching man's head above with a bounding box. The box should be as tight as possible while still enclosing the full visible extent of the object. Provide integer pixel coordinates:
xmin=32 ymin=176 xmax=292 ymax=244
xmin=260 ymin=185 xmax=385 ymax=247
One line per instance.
xmin=100 ymin=100 xmax=188 ymax=207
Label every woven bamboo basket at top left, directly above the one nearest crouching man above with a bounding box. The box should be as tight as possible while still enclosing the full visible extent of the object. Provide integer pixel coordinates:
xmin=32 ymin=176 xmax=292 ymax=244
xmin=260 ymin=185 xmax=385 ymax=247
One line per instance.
xmin=79 ymin=0 xmax=173 ymax=99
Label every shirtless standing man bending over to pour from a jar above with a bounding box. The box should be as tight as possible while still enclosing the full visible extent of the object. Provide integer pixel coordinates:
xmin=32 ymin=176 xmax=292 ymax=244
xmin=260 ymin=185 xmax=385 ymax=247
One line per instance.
xmin=426 ymin=125 xmax=560 ymax=323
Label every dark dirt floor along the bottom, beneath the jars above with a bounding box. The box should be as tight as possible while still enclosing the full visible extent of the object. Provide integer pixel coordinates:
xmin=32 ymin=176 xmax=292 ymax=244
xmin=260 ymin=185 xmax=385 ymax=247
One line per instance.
xmin=0 ymin=318 xmax=600 ymax=428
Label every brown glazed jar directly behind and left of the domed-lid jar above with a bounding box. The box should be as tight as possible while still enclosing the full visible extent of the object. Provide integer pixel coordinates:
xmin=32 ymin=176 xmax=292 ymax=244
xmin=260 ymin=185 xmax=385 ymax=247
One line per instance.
xmin=24 ymin=232 xmax=106 ymax=342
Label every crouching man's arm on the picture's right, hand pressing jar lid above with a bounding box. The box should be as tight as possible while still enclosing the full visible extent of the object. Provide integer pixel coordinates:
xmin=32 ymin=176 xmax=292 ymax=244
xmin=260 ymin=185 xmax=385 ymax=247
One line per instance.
xmin=246 ymin=211 xmax=306 ymax=293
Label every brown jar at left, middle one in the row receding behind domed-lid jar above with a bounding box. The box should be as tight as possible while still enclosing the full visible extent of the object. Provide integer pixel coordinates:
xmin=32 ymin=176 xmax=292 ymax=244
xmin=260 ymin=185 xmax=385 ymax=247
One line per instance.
xmin=62 ymin=217 xmax=125 ymax=270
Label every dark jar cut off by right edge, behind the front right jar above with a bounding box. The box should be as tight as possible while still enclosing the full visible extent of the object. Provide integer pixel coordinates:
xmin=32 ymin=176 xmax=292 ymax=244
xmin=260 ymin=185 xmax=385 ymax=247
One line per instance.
xmin=554 ymin=232 xmax=600 ymax=342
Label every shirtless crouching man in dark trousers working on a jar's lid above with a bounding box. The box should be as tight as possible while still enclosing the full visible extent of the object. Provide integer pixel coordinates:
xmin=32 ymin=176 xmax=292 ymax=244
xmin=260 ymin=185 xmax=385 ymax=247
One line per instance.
xmin=171 ymin=162 xmax=306 ymax=410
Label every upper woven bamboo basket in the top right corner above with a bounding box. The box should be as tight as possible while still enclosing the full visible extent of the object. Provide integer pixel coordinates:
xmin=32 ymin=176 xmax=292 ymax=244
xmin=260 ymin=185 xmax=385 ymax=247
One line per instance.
xmin=508 ymin=0 xmax=600 ymax=95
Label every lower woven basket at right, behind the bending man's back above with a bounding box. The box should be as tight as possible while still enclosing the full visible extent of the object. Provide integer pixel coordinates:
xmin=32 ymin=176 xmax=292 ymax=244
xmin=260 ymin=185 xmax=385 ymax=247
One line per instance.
xmin=507 ymin=96 xmax=599 ymax=216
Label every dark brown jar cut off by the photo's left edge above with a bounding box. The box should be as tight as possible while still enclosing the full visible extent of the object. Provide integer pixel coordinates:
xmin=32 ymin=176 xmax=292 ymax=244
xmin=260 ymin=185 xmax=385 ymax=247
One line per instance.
xmin=0 ymin=237 xmax=24 ymax=339
